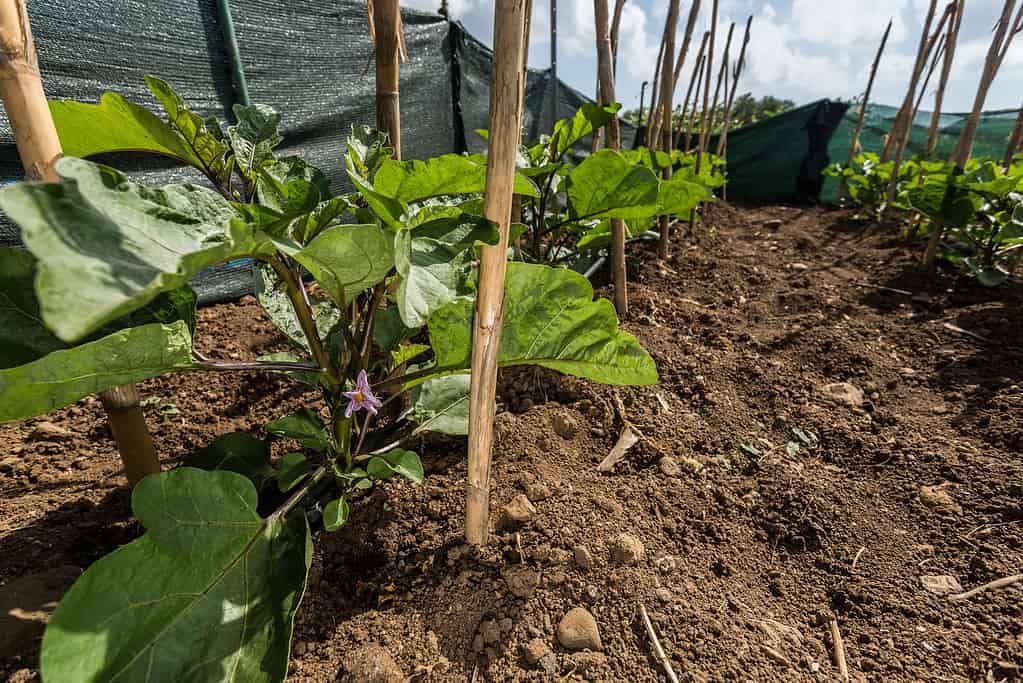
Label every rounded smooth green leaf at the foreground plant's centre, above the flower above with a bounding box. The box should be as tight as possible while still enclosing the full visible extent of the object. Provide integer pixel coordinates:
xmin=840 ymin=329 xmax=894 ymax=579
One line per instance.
xmin=295 ymin=225 xmax=394 ymax=306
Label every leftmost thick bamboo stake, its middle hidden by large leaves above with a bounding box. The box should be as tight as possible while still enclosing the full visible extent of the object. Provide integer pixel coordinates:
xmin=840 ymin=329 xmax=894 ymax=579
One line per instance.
xmin=0 ymin=0 xmax=160 ymax=487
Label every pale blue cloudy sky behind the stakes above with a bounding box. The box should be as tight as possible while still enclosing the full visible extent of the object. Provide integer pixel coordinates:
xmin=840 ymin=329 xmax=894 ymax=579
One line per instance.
xmin=401 ymin=0 xmax=1023 ymax=111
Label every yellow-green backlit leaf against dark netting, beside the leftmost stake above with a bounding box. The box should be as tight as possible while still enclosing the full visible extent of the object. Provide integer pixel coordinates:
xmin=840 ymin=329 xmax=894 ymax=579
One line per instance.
xmin=49 ymin=92 xmax=199 ymax=166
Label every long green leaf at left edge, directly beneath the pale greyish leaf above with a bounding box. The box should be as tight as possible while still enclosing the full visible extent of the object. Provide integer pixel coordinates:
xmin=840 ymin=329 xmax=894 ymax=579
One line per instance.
xmin=0 ymin=321 xmax=191 ymax=422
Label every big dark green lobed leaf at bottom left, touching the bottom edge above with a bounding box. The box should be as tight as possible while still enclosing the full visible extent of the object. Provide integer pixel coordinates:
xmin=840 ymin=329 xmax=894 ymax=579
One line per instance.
xmin=40 ymin=467 xmax=312 ymax=683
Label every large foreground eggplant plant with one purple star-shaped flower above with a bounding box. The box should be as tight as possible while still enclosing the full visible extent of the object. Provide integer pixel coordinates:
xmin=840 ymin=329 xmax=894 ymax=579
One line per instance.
xmin=0 ymin=78 xmax=658 ymax=683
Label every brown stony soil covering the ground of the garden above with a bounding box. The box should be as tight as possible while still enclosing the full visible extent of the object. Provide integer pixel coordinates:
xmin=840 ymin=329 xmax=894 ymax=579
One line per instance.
xmin=0 ymin=206 xmax=1023 ymax=682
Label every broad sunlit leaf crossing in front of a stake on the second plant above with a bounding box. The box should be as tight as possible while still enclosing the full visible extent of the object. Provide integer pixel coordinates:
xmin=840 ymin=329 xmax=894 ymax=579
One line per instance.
xmin=565 ymin=149 xmax=660 ymax=220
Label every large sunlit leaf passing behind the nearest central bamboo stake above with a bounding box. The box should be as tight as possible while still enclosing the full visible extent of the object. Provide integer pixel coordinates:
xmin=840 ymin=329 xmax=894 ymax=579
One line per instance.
xmin=430 ymin=263 xmax=657 ymax=384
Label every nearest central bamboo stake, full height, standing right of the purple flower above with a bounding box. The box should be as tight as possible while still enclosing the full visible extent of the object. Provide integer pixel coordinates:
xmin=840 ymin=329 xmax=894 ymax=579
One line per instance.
xmin=465 ymin=0 xmax=525 ymax=545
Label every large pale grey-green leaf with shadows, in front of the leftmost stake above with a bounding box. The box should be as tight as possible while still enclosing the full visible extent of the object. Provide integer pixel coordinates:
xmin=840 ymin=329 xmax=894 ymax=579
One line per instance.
xmin=0 ymin=157 xmax=269 ymax=342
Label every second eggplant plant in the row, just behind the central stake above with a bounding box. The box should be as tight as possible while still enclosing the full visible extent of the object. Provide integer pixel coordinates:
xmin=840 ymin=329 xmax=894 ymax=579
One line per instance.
xmin=477 ymin=103 xmax=724 ymax=265
